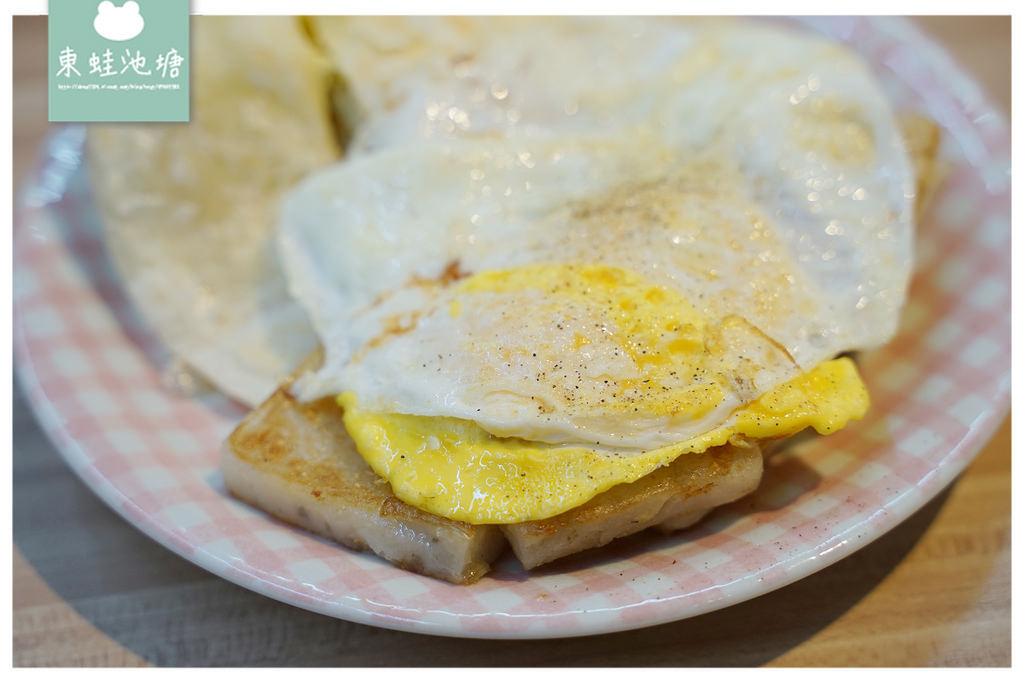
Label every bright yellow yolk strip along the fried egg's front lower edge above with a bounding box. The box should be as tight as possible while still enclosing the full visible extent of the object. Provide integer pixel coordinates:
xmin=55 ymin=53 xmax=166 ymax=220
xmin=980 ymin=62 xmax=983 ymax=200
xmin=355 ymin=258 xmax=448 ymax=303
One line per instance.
xmin=338 ymin=357 xmax=868 ymax=524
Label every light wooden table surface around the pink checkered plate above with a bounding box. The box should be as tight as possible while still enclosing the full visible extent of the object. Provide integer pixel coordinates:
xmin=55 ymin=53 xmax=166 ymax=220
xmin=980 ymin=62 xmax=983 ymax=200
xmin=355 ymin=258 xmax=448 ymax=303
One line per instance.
xmin=13 ymin=16 xmax=1011 ymax=667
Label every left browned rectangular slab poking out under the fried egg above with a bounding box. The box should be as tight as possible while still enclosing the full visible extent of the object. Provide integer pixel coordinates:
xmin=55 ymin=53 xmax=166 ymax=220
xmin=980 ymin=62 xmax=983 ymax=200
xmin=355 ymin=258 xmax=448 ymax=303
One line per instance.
xmin=221 ymin=353 xmax=505 ymax=583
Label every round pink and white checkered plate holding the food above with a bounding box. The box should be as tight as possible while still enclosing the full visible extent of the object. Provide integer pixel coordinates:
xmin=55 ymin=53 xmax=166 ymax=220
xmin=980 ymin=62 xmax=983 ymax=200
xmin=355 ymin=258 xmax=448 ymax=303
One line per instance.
xmin=13 ymin=17 xmax=1010 ymax=638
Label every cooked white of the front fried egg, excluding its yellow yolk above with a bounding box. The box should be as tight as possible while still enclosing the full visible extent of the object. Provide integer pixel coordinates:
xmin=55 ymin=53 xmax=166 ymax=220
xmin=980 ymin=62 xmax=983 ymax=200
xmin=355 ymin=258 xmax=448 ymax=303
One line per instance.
xmin=279 ymin=18 xmax=913 ymax=450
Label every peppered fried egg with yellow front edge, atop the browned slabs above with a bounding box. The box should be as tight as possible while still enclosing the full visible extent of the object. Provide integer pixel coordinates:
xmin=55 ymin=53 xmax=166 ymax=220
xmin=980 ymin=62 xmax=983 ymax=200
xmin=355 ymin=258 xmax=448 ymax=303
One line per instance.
xmin=279 ymin=24 xmax=914 ymax=523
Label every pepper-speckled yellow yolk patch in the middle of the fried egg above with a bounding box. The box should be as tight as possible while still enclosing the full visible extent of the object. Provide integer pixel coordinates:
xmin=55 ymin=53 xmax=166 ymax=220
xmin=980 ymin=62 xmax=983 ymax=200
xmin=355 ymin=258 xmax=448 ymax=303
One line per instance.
xmin=450 ymin=263 xmax=735 ymax=424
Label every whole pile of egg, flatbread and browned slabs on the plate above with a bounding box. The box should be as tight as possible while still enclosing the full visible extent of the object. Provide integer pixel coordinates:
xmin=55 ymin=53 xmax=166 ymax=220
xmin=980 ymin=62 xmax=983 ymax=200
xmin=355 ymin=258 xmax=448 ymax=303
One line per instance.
xmin=89 ymin=17 xmax=936 ymax=583
